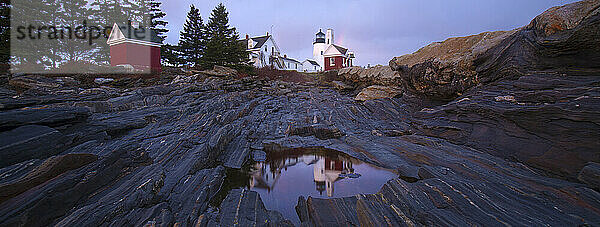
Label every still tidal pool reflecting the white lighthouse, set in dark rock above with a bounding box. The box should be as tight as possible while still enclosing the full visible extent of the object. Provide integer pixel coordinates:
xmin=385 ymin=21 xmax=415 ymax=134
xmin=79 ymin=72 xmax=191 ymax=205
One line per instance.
xmin=211 ymin=148 xmax=397 ymax=224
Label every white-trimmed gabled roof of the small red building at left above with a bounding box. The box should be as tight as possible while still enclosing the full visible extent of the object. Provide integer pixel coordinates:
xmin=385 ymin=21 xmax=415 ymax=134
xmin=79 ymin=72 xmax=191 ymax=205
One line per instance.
xmin=106 ymin=23 xmax=161 ymax=46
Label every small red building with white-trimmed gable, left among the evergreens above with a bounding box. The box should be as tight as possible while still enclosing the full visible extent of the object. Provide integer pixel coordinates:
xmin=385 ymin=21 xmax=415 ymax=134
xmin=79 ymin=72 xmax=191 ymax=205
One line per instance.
xmin=107 ymin=23 xmax=161 ymax=72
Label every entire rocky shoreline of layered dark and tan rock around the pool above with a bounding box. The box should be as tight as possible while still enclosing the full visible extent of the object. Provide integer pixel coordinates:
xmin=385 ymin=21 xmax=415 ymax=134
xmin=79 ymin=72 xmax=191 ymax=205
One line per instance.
xmin=0 ymin=1 xmax=600 ymax=226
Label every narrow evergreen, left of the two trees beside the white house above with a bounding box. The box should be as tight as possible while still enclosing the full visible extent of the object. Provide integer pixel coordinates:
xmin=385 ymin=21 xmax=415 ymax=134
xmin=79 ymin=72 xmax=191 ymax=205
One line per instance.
xmin=179 ymin=5 xmax=206 ymax=66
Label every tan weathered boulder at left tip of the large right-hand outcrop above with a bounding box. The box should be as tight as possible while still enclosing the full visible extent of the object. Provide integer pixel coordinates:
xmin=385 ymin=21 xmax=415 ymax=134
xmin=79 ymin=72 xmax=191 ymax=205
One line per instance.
xmin=390 ymin=30 xmax=516 ymax=100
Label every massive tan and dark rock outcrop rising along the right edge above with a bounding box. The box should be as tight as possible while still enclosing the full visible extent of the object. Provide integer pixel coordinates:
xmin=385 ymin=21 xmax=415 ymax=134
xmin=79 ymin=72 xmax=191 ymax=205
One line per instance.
xmin=404 ymin=1 xmax=600 ymax=180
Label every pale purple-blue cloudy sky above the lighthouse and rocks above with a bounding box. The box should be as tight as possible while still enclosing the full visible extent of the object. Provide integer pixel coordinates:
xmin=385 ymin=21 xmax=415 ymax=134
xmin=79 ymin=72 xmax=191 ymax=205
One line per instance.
xmin=162 ymin=0 xmax=575 ymax=66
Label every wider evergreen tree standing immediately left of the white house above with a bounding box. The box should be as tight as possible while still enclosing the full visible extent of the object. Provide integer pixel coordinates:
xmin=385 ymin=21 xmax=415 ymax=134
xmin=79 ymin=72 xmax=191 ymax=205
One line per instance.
xmin=202 ymin=3 xmax=248 ymax=68
